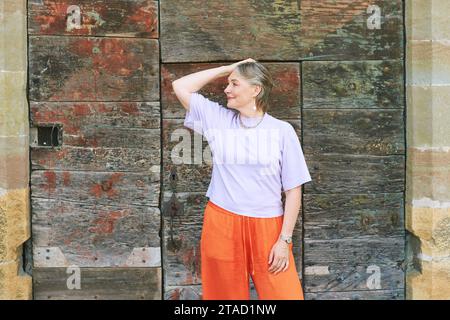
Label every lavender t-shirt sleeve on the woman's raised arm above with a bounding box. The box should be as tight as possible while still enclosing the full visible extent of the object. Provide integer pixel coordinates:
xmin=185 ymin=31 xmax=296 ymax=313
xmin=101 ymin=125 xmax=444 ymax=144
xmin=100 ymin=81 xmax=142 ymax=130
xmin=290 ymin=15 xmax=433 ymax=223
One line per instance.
xmin=184 ymin=92 xmax=232 ymax=135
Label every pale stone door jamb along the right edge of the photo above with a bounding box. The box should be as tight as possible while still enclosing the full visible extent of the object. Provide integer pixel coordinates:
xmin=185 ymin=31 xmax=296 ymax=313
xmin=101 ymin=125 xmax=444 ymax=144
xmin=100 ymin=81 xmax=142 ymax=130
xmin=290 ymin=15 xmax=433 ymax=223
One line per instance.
xmin=406 ymin=0 xmax=450 ymax=299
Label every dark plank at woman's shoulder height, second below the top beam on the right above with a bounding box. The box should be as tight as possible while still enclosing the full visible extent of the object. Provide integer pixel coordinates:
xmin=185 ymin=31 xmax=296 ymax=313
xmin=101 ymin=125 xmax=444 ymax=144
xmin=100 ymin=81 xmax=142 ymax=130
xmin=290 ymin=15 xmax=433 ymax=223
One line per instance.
xmin=303 ymin=108 xmax=405 ymax=157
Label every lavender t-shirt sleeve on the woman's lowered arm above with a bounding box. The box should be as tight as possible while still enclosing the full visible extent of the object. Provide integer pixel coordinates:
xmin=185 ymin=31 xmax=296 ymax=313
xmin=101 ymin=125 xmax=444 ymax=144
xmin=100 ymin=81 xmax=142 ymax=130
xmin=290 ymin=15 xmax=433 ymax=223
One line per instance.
xmin=281 ymin=123 xmax=312 ymax=191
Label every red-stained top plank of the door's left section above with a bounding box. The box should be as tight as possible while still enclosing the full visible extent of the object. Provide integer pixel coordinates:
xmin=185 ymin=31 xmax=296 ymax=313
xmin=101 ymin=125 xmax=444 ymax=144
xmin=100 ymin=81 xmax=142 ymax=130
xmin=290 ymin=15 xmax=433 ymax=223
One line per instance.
xmin=28 ymin=0 xmax=158 ymax=38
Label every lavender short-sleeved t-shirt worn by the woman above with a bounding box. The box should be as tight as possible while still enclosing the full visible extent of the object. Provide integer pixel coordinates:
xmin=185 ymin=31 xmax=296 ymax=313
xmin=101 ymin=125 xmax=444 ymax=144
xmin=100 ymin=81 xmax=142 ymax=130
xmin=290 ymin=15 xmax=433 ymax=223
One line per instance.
xmin=184 ymin=92 xmax=311 ymax=218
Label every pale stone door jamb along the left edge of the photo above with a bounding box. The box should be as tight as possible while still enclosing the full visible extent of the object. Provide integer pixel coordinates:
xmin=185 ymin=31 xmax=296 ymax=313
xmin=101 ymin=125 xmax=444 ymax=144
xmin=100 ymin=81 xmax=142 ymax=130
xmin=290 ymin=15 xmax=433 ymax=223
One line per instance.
xmin=0 ymin=0 xmax=32 ymax=299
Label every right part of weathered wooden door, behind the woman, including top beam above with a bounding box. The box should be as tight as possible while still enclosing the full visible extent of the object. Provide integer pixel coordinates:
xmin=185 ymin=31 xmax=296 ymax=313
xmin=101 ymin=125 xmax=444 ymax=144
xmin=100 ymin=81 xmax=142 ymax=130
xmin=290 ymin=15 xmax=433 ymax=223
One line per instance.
xmin=160 ymin=0 xmax=405 ymax=299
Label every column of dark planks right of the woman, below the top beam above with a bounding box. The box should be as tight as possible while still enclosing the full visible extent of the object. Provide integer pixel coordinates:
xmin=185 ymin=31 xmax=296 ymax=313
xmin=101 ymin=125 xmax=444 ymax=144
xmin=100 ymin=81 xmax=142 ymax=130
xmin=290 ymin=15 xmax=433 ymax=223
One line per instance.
xmin=302 ymin=56 xmax=405 ymax=300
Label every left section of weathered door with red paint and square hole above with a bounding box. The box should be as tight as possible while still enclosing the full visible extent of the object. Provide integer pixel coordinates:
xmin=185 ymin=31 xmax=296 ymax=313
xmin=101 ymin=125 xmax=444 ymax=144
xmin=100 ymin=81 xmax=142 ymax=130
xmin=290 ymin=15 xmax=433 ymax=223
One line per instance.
xmin=28 ymin=0 xmax=161 ymax=299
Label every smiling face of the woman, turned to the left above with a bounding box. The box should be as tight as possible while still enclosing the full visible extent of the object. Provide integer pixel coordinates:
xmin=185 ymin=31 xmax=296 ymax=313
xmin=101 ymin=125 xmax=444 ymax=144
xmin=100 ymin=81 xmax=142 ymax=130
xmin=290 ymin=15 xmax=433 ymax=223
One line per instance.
xmin=224 ymin=71 xmax=259 ymax=110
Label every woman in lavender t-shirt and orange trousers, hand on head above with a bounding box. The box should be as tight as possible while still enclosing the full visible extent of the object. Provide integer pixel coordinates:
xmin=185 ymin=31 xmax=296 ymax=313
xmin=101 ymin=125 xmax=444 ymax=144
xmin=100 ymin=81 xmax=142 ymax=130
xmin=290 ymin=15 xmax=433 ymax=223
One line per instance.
xmin=172 ymin=59 xmax=311 ymax=300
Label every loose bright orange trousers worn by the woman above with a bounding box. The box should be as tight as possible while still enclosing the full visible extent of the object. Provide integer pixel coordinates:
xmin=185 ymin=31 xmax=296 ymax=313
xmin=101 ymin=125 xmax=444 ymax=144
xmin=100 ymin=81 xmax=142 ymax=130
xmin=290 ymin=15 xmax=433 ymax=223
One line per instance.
xmin=200 ymin=201 xmax=304 ymax=300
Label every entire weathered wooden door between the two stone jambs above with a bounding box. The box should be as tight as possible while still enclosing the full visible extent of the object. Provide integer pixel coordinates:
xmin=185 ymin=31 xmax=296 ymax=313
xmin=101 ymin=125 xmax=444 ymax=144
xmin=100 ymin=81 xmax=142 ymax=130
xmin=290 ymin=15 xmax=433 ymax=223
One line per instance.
xmin=28 ymin=0 xmax=405 ymax=299
